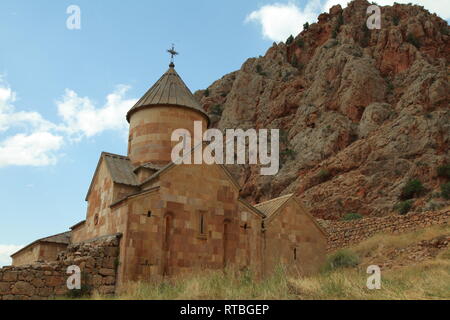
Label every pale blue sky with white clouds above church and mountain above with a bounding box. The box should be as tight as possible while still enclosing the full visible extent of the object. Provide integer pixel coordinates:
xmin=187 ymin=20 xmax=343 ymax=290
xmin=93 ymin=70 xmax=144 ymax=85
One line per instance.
xmin=0 ymin=0 xmax=450 ymax=266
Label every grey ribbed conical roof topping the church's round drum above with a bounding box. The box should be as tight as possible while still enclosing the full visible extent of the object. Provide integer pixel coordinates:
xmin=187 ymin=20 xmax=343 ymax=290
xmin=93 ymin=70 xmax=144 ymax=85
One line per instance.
xmin=127 ymin=64 xmax=209 ymax=123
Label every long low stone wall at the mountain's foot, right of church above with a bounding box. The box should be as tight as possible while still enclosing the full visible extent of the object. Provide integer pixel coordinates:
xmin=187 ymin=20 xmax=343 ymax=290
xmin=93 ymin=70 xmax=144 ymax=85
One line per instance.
xmin=317 ymin=208 xmax=450 ymax=251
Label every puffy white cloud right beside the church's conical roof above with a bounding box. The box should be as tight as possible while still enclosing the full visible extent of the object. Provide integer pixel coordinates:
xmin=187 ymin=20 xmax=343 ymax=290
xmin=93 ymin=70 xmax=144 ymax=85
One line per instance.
xmin=57 ymin=85 xmax=137 ymax=137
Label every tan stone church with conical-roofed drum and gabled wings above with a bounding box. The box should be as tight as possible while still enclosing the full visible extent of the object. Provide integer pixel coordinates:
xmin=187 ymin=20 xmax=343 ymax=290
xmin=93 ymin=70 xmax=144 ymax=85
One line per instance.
xmin=12 ymin=63 xmax=326 ymax=284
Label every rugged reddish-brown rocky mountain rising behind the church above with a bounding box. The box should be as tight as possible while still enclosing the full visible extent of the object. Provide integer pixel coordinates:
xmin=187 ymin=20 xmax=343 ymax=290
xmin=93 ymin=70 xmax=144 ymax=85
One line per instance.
xmin=195 ymin=0 xmax=450 ymax=219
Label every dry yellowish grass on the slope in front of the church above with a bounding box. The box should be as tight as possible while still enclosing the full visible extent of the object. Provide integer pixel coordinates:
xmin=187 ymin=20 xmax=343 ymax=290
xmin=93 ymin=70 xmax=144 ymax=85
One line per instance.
xmin=92 ymin=225 xmax=450 ymax=300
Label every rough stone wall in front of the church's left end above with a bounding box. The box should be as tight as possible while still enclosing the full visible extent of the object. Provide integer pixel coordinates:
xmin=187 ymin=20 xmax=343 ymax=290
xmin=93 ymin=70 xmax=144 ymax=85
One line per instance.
xmin=0 ymin=234 xmax=121 ymax=300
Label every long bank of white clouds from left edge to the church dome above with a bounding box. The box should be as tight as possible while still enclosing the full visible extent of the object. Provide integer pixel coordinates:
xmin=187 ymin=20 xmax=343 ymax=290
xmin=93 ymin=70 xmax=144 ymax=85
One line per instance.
xmin=0 ymin=75 xmax=137 ymax=168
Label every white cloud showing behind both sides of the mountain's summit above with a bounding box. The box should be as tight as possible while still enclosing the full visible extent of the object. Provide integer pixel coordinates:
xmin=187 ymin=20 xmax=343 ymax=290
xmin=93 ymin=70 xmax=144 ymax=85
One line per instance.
xmin=245 ymin=0 xmax=450 ymax=42
